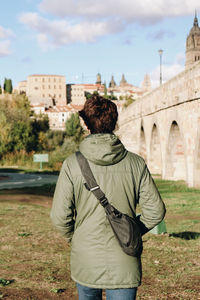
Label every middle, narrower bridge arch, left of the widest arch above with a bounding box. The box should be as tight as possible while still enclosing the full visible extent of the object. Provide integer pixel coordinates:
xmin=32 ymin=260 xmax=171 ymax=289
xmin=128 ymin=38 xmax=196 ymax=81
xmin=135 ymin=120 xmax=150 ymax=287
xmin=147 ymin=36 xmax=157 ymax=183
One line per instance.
xmin=148 ymin=123 xmax=162 ymax=174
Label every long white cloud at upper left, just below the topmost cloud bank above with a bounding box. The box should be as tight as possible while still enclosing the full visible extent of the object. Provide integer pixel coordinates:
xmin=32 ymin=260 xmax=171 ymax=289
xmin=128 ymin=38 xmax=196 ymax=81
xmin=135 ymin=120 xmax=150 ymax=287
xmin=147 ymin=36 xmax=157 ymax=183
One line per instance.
xmin=19 ymin=13 xmax=123 ymax=50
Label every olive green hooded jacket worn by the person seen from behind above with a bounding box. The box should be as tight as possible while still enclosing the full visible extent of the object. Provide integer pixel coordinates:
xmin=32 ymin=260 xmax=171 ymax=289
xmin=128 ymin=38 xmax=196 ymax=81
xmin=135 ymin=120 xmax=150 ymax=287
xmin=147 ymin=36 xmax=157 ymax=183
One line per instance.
xmin=51 ymin=134 xmax=165 ymax=289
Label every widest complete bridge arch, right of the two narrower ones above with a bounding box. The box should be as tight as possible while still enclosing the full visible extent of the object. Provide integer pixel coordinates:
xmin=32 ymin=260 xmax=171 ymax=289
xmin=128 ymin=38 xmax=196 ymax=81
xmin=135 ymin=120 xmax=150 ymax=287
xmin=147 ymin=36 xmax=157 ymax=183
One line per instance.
xmin=165 ymin=120 xmax=187 ymax=181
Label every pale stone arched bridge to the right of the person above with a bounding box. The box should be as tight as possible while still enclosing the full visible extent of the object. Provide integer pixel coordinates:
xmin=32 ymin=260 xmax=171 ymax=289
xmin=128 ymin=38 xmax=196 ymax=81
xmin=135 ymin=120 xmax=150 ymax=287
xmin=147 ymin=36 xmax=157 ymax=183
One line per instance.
xmin=117 ymin=62 xmax=200 ymax=187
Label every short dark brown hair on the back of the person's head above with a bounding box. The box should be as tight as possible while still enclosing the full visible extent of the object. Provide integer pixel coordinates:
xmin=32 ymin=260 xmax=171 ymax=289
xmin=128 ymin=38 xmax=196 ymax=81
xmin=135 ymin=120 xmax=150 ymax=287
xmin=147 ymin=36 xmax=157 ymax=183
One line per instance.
xmin=79 ymin=94 xmax=118 ymax=133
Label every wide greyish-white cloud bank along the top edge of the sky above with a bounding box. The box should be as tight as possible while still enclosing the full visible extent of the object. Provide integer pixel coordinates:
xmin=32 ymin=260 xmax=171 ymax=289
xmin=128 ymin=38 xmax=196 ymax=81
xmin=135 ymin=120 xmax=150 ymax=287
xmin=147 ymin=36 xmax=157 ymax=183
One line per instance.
xmin=39 ymin=0 xmax=200 ymax=25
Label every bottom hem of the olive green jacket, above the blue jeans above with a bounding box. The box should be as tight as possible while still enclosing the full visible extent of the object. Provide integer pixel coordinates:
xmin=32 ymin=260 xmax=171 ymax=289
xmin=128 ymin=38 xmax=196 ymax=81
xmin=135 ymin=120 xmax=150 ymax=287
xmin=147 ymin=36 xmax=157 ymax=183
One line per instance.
xmin=71 ymin=275 xmax=141 ymax=289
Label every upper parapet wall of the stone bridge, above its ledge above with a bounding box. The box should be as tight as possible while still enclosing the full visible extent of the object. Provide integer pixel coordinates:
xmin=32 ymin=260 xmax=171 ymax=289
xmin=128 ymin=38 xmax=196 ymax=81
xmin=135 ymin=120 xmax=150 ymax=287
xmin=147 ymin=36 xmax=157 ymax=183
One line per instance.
xmin=119 ymin=62 xmax=200 ymax=126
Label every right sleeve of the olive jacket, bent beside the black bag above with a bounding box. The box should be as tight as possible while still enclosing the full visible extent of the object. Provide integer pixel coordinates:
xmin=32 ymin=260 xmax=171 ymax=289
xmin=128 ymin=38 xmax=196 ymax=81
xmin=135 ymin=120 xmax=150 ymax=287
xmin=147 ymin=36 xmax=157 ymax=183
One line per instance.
xmin=138 ymin=165 xmax=166 ymax=234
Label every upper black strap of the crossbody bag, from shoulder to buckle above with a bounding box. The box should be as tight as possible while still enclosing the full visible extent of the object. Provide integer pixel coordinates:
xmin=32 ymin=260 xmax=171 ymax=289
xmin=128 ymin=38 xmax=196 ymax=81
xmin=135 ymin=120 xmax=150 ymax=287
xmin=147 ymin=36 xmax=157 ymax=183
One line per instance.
xmin=76 ymin=151 xmax=108 ymax=207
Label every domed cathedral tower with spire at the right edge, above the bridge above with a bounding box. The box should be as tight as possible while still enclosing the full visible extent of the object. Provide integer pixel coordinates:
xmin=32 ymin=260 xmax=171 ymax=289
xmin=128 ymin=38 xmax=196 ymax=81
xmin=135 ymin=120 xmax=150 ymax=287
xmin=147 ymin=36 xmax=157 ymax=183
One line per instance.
xmin=185 ymin=12 xmax=200 ymax=68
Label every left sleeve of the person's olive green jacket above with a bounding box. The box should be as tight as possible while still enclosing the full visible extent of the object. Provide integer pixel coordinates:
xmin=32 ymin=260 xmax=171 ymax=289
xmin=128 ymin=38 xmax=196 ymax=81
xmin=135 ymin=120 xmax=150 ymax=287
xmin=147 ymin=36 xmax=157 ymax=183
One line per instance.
xmin=50 ymin=161 xmax=75 ymax=242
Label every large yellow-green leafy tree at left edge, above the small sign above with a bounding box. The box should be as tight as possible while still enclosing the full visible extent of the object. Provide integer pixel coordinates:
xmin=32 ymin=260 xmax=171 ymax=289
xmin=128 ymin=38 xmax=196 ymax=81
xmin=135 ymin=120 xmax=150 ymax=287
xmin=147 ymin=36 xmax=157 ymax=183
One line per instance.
xmin=0 ymin=95 xmax=49 ymax=153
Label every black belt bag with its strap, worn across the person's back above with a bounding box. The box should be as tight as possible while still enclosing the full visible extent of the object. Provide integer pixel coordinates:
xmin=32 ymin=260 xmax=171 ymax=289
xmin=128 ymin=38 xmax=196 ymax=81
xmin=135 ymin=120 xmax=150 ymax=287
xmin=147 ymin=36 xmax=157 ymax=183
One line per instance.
xmin=76 ymin=151 xmax=142 ymax=257
